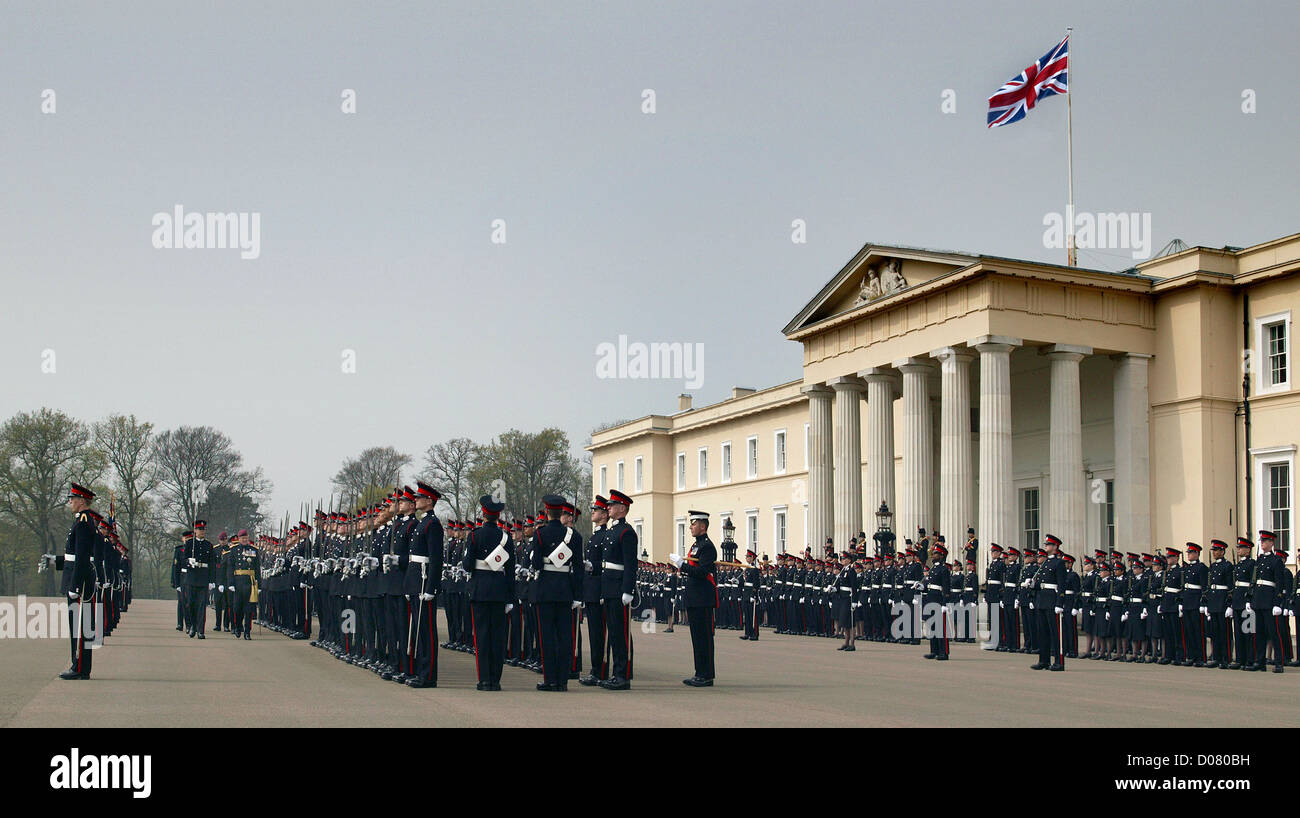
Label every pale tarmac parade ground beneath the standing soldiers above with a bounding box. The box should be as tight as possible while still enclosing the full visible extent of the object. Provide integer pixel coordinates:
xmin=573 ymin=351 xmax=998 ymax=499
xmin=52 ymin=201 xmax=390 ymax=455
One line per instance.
xmin=0 ymin=598 xmax=1300 ymax=728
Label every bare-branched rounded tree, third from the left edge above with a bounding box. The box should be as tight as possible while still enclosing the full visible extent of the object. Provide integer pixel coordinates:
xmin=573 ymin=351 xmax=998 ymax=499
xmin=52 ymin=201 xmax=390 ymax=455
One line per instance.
xmin=153 ymin=427 xmax=248 ymax=527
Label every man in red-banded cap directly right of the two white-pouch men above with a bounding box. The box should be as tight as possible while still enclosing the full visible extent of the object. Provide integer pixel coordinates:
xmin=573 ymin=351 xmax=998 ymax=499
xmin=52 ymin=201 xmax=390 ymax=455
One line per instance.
xmin=601 ymin=489 xmax=637 ymax=691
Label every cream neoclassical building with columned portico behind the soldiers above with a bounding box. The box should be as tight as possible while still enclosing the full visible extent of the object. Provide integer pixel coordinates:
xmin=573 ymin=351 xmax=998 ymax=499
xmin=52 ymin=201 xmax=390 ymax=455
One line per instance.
xmin=589 ymin=234 xmax=1300 ymax=568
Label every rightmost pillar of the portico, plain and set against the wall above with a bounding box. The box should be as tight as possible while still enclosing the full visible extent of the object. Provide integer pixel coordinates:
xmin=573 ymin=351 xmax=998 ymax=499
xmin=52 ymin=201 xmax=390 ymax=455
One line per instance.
xmin=1112 ymin=352 xmax=1154 ymax=550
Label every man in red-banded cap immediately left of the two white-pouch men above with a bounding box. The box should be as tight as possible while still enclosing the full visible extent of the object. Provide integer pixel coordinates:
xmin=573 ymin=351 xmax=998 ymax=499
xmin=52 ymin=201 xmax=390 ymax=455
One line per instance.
xmin=403 ymin=480 xmax=444 ymax=688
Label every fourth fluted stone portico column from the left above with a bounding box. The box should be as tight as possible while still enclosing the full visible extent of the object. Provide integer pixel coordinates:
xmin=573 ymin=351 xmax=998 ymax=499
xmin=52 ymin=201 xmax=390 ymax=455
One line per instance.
xmin=893 ymin=358 xmax=937 ymax=548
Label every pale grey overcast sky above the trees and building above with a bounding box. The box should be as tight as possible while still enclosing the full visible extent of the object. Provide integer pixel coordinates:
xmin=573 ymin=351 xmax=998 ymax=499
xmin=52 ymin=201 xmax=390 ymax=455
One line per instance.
xmin=0 ymin=0 xmax=1300 ymax=516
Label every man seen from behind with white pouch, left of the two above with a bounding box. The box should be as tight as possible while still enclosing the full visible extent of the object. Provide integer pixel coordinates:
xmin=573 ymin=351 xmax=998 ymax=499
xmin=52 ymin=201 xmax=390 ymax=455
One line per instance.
xmin=460 ymin=494 xmax=515 ymax=691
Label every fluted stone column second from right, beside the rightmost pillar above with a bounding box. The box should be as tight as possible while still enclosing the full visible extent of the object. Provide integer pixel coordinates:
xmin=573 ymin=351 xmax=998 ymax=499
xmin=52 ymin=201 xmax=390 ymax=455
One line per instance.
xmin=1043 ymin=343 xmax=1092 ymax=554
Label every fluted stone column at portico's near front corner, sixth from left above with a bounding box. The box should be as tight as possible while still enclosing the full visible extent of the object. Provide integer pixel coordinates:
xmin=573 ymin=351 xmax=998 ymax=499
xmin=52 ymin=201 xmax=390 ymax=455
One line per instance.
xmin=969 ymin=336 xmax=1021 ymax=577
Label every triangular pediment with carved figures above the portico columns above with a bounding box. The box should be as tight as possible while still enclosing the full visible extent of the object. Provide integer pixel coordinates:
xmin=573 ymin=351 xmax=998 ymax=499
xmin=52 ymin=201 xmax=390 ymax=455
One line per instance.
xmin=781 ymin=244 xmax=978 ymax=336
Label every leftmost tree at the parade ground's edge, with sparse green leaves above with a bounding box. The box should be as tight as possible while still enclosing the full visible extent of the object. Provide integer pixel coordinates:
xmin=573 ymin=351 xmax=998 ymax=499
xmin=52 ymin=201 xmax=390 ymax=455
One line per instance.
xmin=0 ymin=408 xmax=104 ymax=593
